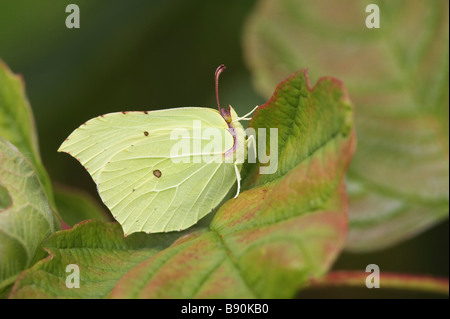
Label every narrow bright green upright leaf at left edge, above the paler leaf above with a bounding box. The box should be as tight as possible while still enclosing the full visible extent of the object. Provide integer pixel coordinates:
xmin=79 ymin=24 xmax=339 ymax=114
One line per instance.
xmin=0 ymin=60 xmax=56 ymax=218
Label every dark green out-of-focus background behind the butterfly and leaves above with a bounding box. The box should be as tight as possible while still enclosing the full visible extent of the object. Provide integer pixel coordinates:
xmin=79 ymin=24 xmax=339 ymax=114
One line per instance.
xmin=0 ymin=0 xmax=449 ymax=296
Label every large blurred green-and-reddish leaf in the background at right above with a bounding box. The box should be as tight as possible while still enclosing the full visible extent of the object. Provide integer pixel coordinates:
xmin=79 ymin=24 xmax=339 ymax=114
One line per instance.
xmin=244 ymin=0 xmax=449 ymax=251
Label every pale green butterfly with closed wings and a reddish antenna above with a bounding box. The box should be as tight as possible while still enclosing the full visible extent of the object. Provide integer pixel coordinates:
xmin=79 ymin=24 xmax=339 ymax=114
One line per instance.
xmin=58 ymin=65 xmax=257 ymax=235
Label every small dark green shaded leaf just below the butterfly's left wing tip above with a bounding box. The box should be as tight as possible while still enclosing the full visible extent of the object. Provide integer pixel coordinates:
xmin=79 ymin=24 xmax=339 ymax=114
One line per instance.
xmin=54 ymin=185 xmax=113 ymax=226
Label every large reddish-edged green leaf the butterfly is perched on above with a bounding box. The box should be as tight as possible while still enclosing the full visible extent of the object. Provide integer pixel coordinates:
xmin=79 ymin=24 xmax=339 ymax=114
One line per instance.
xmin=11 ymin=70 xmax=354 ymax=298
